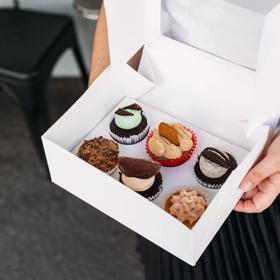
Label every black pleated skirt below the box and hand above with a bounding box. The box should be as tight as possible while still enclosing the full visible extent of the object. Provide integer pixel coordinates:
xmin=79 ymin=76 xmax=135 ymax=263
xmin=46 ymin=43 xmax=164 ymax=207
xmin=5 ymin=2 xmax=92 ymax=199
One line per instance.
xmin=138 ymin=197 xmax=280 ymax=280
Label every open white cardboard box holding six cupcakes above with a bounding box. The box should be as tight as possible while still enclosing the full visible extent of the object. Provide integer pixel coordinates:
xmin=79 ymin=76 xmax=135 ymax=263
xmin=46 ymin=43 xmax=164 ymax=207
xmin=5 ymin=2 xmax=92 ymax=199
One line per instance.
xmin=42 ymin=0 xmax=280 ymax=265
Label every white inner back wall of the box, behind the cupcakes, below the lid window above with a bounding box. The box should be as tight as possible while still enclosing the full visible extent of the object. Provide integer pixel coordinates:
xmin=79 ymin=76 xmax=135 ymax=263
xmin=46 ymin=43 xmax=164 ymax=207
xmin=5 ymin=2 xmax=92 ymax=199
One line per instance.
xmin=139 ymin=41 xmax=254 ymax=149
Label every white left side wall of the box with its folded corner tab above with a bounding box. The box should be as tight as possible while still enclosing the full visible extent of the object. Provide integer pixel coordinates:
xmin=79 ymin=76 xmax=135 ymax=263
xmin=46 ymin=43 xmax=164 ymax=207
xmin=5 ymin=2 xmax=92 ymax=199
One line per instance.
xmin=42 ymin=65 xmax=155 ymax=150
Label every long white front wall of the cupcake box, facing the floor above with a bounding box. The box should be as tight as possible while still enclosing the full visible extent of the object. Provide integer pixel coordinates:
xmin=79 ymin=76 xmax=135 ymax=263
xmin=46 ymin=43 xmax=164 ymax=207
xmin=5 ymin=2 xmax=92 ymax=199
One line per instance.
xmin=42 ymin=137 xmax=197 ymax=264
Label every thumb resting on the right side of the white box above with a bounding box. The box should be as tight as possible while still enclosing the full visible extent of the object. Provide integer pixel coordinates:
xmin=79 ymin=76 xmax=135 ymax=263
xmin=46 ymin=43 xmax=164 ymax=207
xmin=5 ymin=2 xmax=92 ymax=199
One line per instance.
xmin=240 ymin=156 xmax=280 ymax=192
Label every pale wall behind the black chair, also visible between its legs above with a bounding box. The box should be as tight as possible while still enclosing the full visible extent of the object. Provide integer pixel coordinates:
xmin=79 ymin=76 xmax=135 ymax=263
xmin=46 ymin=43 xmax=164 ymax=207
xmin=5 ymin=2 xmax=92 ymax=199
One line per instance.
xmin=0 ymin=0 xmax=95 ymax=76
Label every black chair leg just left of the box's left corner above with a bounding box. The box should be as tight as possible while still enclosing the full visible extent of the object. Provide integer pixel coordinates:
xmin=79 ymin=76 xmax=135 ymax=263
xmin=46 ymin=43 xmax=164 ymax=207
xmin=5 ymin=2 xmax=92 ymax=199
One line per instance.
xmin=14 ymin=82 xmax=50 ymax=164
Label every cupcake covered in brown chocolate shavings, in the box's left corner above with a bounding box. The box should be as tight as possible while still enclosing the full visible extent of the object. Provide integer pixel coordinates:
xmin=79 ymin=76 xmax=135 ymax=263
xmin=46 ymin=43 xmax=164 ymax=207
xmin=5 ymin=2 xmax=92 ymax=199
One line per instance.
xmin=77 ymin=136 xmax=119 ymax=175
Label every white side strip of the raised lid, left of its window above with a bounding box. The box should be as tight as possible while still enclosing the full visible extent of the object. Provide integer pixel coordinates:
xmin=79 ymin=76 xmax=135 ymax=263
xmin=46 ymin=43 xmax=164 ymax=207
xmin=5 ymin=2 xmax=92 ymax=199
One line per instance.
xmin=104 ymin=0 xmax=160 ymax=67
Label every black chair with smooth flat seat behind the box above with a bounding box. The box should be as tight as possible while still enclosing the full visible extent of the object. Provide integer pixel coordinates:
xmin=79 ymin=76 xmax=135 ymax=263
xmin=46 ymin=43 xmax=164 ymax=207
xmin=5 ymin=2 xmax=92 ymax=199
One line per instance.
xmin=0 ymin=0 xmax=88 ymax=168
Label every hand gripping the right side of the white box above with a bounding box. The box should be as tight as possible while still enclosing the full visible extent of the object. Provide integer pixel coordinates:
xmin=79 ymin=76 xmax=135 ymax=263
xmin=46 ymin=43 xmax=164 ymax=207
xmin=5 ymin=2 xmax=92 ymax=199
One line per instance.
xmin=234 ymin=134 xmax=280 ymax=213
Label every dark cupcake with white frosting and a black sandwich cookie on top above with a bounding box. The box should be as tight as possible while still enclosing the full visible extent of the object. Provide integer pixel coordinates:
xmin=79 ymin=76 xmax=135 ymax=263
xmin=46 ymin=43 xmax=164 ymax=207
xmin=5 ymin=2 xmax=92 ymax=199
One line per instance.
xmin=194 ymin=147 xmax=237 ymax=189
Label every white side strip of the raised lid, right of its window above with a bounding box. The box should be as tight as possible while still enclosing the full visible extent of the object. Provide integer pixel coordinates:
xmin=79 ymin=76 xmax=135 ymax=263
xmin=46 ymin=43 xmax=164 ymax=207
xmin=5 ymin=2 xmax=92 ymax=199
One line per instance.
xmin=248 ymin=5 xmax=280 ymax=134
